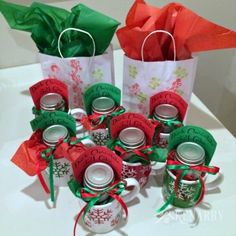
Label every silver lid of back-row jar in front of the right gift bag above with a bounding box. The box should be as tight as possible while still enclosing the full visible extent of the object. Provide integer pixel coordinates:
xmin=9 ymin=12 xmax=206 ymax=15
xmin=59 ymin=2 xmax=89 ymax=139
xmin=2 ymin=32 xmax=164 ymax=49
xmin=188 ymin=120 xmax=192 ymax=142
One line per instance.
xmin=154 ymin=104 xmax=178 ymax=120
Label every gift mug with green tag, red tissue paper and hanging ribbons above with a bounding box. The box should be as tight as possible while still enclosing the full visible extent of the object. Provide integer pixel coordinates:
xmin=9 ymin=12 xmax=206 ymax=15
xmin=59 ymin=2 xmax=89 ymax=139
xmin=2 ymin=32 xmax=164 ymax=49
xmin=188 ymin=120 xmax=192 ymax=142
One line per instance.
xmin=12 ymin=111 xmax=90 ymax=201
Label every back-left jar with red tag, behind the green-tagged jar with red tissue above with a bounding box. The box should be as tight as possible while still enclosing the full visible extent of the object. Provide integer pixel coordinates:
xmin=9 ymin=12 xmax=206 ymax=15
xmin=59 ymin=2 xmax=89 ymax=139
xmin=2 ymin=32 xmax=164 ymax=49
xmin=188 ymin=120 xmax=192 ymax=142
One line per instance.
xmin=29 ymin=78 xmax=69 ymax=116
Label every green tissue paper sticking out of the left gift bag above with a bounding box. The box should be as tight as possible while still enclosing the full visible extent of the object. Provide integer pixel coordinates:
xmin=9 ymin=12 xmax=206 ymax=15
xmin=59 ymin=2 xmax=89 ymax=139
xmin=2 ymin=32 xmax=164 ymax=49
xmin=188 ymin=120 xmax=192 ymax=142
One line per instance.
xmin=0 ymin=1 xmax=120 ymax=57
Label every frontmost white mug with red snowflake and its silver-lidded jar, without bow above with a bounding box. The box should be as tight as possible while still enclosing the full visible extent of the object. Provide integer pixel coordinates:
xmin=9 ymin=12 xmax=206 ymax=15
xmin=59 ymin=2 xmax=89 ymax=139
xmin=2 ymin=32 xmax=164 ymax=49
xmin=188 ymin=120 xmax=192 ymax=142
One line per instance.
xmin=82 ymin=162 xmax=140 ymax=234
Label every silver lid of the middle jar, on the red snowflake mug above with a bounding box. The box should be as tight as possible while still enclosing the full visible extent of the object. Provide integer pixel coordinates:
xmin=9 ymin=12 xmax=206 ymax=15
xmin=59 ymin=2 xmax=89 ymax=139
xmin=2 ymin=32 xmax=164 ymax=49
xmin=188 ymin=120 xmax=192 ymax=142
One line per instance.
xmin=119 ymin=127 xmax=146 ymax=149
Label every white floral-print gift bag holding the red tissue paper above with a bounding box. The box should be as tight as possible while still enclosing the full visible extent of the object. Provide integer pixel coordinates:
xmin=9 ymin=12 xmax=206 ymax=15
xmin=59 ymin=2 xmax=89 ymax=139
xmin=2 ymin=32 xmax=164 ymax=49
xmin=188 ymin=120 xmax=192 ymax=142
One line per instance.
xmin=123 ymin=30 xmax=197 ymax=115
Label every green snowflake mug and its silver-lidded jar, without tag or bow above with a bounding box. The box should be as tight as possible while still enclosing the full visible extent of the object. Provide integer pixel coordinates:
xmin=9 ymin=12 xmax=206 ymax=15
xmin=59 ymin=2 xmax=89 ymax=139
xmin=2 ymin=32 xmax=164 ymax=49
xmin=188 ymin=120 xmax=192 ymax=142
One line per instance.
xmin=163 ymin=142 xmax=205 ymax=208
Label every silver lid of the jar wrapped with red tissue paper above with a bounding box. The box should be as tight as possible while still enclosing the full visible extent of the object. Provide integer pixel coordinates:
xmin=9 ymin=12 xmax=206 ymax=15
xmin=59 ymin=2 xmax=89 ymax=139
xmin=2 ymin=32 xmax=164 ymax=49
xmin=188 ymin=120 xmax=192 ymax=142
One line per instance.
xmin=43 ymin=125 xmax=69 ymax=146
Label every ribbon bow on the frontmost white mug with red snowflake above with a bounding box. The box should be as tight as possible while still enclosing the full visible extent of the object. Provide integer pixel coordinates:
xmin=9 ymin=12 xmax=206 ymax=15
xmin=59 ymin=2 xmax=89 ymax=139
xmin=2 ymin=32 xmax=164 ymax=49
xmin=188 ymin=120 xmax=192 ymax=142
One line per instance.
xmin=68 ymin=179 xmax=128 ymax=236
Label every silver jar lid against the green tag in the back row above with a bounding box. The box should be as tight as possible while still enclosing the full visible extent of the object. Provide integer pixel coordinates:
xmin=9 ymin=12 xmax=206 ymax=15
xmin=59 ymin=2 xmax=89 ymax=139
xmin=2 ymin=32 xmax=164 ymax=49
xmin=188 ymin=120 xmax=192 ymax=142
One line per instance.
xmin=92 ymin=97 xmax=116 ymax=114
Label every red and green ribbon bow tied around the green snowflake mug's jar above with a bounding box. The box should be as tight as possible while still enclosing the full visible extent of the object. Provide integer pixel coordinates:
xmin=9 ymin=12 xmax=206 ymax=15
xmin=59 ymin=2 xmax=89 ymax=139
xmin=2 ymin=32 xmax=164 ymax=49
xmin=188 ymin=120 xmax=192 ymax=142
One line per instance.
xmin=157 ymin=150 xmax=220 ymax=213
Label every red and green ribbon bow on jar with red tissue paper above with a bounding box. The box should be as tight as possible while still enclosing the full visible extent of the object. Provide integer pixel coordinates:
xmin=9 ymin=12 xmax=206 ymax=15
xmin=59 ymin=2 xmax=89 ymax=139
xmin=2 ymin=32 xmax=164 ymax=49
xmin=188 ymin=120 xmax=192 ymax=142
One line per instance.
xmin=38 ymin=136 xmax=89 ymax=202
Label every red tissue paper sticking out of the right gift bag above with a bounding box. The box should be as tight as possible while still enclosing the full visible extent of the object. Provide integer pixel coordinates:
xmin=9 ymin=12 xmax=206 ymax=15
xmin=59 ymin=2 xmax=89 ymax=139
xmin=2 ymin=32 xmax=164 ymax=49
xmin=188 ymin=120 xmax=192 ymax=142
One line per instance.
xmin=117 ymin=0 xmax=236 ymax=61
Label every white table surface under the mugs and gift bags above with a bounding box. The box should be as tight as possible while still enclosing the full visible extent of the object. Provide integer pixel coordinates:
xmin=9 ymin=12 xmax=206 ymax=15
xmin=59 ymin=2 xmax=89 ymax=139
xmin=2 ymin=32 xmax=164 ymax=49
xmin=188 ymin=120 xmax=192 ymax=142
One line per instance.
xmin=0 ymin=48 xmax=236 ymax=236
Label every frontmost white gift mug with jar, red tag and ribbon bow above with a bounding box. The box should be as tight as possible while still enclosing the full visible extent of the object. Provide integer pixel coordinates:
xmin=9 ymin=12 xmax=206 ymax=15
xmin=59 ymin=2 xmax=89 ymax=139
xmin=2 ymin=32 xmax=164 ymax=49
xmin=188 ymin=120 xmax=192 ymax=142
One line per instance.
xmin=69 ymin=146 xmax=140 ymax=235
